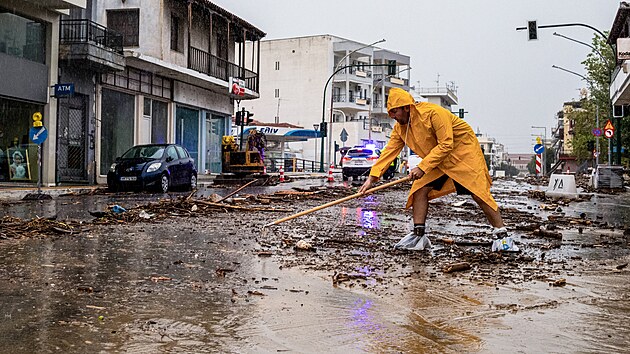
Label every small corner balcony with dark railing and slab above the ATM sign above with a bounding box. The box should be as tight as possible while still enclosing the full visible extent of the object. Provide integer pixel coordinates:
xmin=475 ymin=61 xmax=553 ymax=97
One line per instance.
xmin=59 ymin=19 xmax=125 ymax=72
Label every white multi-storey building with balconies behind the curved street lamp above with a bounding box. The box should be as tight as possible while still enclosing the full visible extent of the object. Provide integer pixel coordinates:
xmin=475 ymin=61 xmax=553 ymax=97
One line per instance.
xmin=241 ymin=35 xmax=410 ymax=168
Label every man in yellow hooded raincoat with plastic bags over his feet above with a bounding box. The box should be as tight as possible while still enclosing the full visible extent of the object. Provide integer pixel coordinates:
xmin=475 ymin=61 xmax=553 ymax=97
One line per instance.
xmin=359 ymin=88 xmax=517 ymax=251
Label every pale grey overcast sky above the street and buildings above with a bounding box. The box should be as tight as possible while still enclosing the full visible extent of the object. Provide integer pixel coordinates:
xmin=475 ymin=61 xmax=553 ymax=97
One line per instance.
xmin=212 ymin=0 xmax=619 ymax=153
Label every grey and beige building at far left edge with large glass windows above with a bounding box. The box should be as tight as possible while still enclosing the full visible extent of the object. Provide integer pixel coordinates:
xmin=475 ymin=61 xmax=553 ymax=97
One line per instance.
xmin=0 ymin=0 xmax=86 ymax=184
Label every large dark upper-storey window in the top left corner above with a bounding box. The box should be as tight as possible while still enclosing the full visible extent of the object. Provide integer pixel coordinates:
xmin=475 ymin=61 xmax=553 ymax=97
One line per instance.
xmin=0 ymin=8 xmax=46 ymax=64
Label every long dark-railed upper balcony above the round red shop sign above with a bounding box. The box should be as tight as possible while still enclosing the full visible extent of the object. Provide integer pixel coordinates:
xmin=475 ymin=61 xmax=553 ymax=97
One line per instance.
xmin=188 ymin=47 xmax=258 ymax=93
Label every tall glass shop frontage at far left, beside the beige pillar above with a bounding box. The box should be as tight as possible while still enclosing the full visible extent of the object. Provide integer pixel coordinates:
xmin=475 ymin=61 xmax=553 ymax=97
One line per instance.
xmin=0 ymin=7 xmax=49 ymax=183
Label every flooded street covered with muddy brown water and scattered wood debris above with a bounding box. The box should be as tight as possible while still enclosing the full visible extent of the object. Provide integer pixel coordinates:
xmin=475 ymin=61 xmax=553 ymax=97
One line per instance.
xmin=0 ymin=180 xmax=630 ymax=353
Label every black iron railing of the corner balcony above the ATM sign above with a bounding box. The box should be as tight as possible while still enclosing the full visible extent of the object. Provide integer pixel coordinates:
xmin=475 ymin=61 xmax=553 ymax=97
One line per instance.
xmin=59 ymin=19 xmax=123 ymax=54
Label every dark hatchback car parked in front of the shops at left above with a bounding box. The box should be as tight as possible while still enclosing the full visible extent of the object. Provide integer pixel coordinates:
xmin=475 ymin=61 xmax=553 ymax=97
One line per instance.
xmin=107 ymin=144 xmax=197 ymax=193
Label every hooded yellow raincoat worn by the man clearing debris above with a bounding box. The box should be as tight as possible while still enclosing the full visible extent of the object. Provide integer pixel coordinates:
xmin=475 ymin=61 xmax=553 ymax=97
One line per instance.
xmin=370 ymin=88 xmax=498 ymax=210
